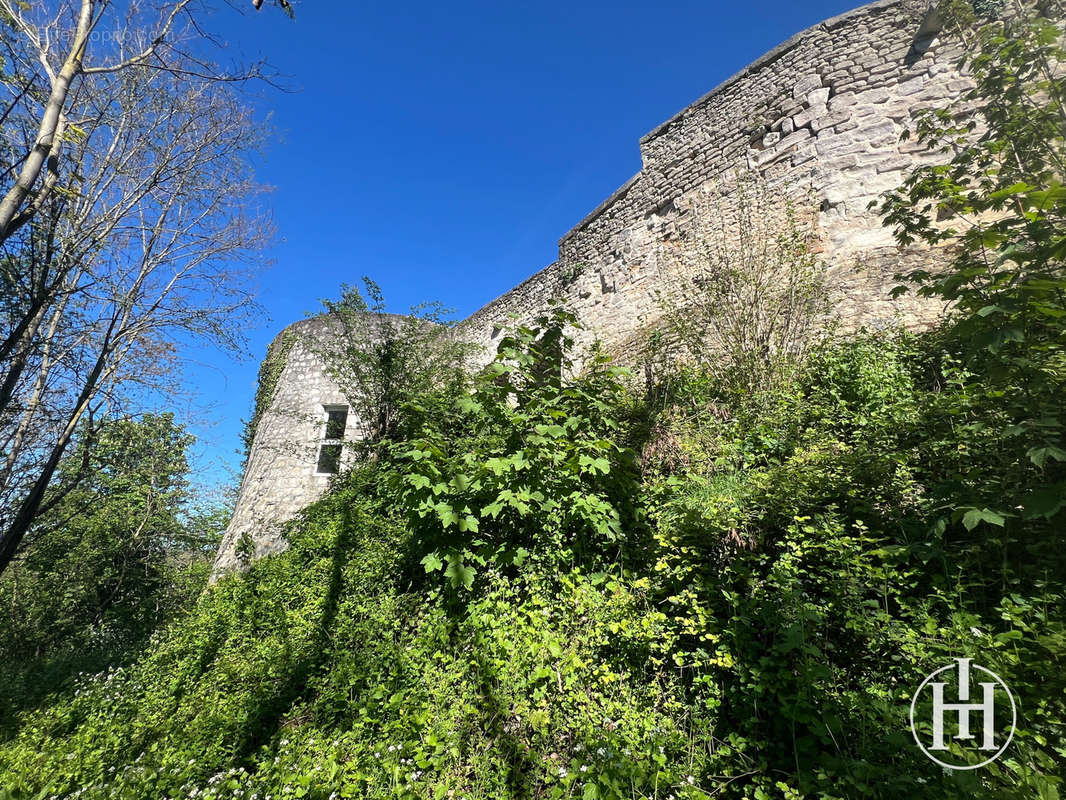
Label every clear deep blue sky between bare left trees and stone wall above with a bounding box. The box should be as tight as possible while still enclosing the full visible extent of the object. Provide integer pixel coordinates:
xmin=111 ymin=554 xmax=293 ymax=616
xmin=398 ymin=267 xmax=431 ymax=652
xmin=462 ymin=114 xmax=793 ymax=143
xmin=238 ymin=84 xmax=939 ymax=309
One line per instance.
xmin=188 ymin=0 xmax=858 ymax=481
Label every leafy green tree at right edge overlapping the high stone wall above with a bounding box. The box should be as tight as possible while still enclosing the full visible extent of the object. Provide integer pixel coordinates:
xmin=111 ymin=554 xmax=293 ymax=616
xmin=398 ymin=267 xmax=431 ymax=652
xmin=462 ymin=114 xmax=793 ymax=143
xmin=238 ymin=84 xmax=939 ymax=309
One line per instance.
xmin=881 ymin=1 xmax=1066 ymax=529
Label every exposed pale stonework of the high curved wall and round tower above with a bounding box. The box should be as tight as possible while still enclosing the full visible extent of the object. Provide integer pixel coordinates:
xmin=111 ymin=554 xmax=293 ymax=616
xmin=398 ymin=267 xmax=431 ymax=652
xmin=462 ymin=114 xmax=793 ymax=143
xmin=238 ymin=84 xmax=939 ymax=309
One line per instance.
xmin=216 ymin=0 xmax=971 ymax=570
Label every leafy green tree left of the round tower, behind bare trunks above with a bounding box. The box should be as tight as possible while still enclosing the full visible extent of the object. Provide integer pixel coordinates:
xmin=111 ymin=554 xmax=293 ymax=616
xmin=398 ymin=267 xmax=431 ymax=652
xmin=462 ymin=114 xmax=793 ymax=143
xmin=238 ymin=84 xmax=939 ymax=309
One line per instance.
xmin=0 ymin=414 xmax=210 ymax=658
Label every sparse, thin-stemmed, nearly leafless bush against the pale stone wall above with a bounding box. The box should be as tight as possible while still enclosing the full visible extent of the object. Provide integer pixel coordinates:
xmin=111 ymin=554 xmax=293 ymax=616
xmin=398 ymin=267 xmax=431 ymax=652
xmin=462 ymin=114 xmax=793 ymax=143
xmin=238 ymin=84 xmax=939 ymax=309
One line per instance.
xmin=649 ymin=173 xmax=828 ymax=389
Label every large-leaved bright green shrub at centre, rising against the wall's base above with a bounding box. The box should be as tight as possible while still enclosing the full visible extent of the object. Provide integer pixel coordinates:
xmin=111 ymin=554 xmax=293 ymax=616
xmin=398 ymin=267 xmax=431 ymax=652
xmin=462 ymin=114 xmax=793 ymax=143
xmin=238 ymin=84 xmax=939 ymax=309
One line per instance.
xmin=394 ymin=309 xmax=636 ymax=589
